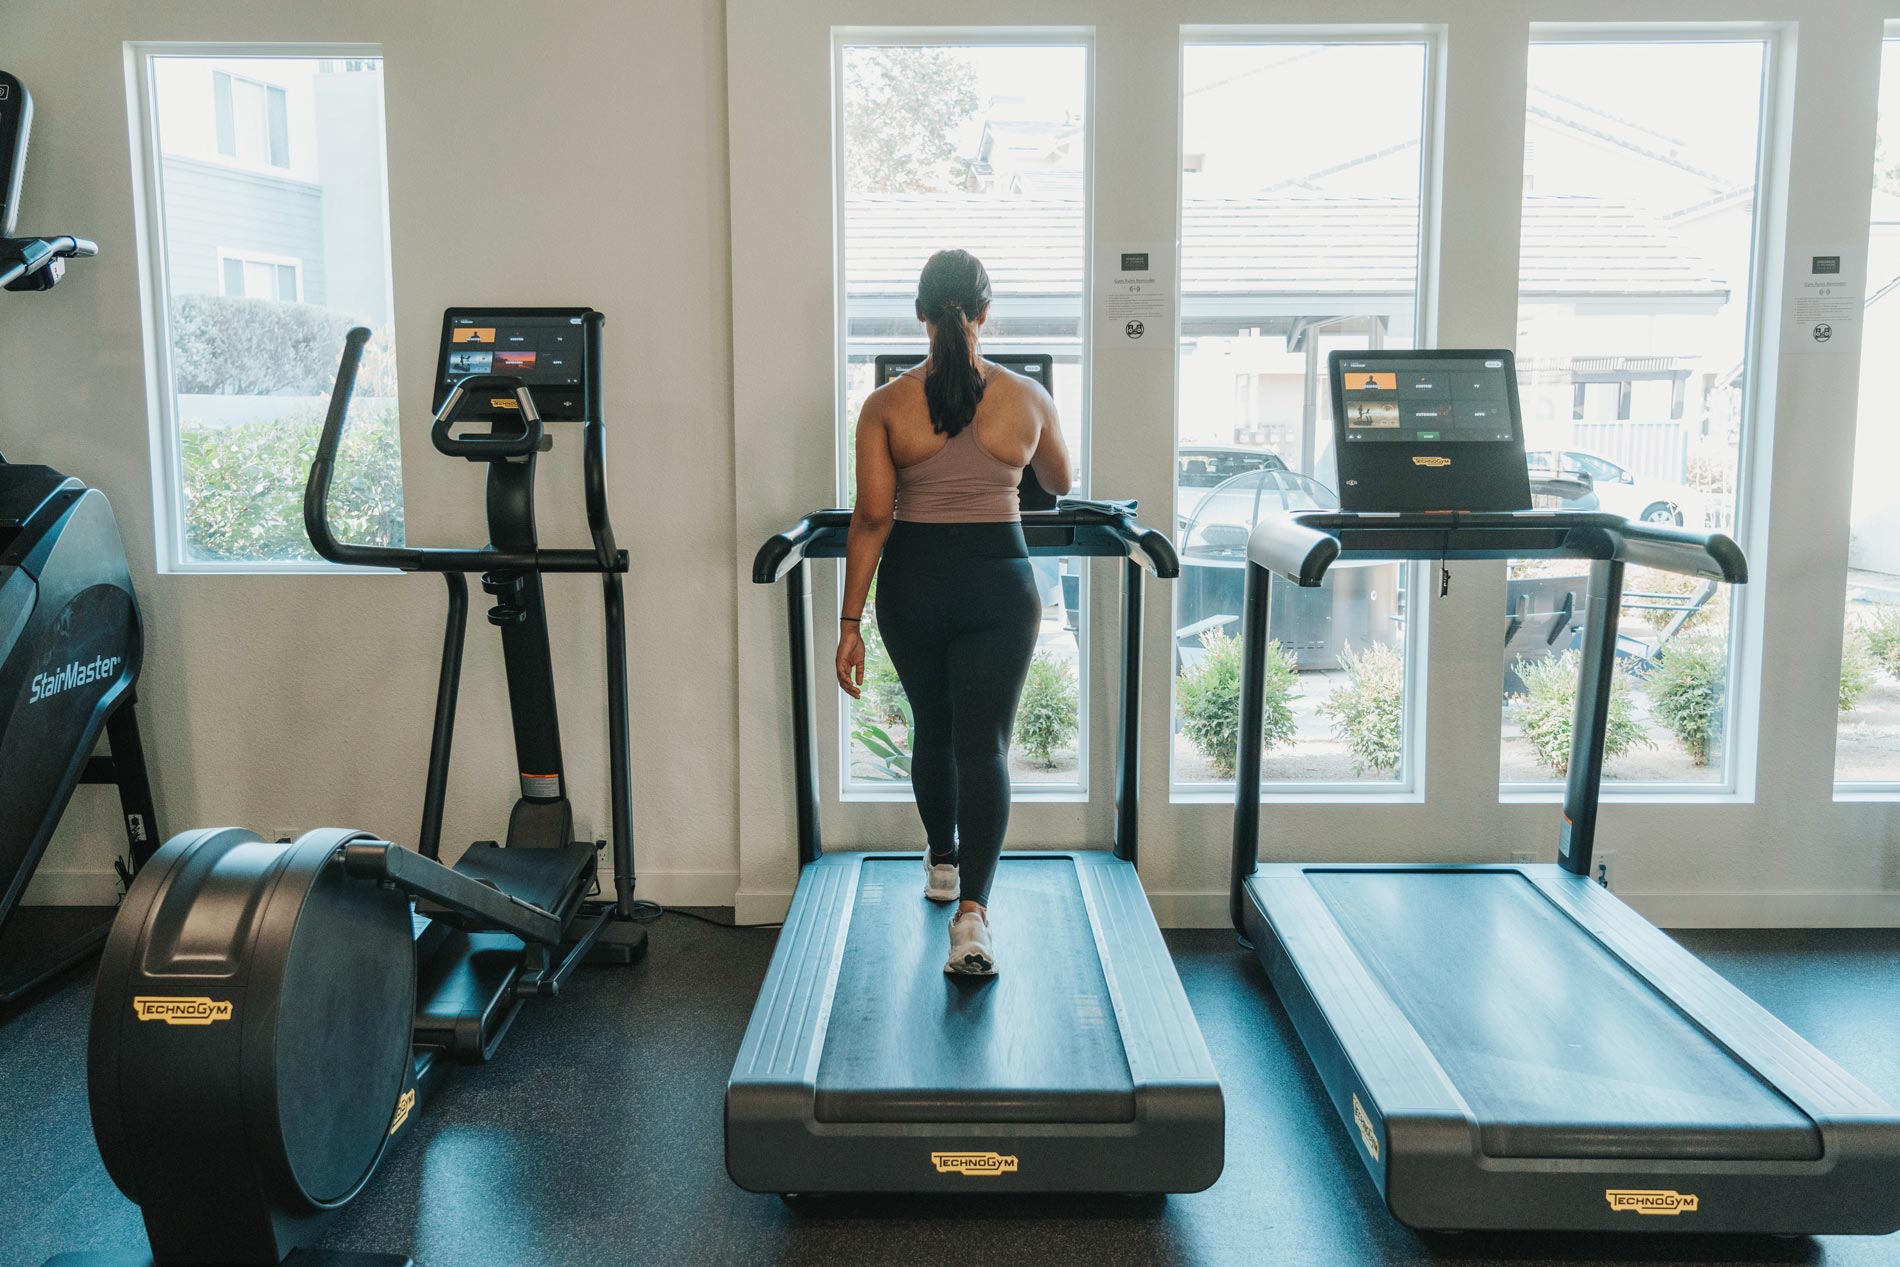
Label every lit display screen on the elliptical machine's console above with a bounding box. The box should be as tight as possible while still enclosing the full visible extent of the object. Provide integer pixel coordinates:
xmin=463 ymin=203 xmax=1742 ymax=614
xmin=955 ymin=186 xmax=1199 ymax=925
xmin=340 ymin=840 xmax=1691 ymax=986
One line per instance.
xmin=435 ymin=308 xmax=591 ymax=422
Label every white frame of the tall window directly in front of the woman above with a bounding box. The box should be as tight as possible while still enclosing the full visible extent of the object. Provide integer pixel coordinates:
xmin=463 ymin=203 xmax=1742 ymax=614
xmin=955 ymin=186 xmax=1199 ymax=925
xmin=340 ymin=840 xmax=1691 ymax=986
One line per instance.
xmin=830 ymin=25 xmax=1102 ymax=805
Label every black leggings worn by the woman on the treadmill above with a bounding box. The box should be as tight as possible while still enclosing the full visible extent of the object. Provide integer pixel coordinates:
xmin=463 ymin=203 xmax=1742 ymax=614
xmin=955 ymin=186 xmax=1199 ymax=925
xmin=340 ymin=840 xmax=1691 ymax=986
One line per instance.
xmin=878 ymin=520 xmax=1043 ymax=904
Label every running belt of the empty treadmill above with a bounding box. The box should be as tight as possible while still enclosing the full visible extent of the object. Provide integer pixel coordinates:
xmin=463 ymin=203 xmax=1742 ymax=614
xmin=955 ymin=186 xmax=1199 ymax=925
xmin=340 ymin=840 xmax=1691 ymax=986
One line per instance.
xmin=1305 ymin=868 xmax=1822 ymax=1161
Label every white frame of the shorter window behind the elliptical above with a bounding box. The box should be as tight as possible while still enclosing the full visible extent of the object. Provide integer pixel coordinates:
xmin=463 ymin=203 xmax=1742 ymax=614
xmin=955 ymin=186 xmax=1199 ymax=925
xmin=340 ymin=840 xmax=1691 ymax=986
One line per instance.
xmin=125 ymin=40 xmax=397 ymax=576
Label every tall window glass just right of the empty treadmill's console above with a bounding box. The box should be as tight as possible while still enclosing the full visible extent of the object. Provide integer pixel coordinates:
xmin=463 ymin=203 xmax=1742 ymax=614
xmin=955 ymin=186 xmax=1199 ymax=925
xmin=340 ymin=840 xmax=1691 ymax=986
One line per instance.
xmin=1499 ymin=38 xmax=1767 ymax=790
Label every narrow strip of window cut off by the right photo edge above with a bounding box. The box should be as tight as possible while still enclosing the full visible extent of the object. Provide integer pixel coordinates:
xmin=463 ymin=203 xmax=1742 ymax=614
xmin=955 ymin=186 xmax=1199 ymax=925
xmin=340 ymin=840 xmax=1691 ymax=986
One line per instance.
xmin=1834 ymin=38 xmax=1900 ymax=796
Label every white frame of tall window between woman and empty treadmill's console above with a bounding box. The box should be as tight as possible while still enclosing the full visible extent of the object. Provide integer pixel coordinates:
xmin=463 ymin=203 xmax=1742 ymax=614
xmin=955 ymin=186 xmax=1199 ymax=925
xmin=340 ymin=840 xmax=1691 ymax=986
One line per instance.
xmin=1167 ymin=23 xmax=1446 ymax=805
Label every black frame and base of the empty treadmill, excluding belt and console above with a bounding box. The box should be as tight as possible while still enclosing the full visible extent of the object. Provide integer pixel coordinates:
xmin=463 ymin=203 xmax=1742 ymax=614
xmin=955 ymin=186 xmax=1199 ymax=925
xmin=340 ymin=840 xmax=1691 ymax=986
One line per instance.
xmin=1231 ymin=511 xmax=1900 ymax=1235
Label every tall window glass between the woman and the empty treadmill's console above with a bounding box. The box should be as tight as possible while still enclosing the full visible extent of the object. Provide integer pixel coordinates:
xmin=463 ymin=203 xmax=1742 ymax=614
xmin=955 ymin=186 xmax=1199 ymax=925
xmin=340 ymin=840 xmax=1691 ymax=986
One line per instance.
xmin=1172 ymin=36 xmax=1431 ymax=792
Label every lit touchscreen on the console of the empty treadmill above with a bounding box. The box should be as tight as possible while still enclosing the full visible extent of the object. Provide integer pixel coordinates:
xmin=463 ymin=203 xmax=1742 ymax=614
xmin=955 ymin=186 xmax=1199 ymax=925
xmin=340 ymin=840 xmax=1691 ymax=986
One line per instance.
xmin=1338 ymin=355 xmax=1514 ymax=444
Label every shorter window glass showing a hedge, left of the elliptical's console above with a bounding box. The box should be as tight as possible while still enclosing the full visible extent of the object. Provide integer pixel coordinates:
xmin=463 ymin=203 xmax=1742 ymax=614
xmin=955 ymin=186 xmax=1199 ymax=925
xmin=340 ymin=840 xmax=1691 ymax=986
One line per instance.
xmin=137 ymin=46 xmax=403 ymax=570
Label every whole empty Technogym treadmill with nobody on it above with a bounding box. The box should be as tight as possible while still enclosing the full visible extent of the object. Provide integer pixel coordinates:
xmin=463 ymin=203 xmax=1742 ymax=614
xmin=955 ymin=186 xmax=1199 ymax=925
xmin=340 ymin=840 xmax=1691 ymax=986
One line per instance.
xmin=1231 ymin=343 xmax=1900 ymax=1235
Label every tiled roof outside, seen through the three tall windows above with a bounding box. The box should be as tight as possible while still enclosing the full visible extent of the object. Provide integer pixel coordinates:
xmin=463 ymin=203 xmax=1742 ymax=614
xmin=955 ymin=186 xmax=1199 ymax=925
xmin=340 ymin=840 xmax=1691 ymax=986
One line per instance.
xmin=846 ymin=190 xmax=1729 ymax=300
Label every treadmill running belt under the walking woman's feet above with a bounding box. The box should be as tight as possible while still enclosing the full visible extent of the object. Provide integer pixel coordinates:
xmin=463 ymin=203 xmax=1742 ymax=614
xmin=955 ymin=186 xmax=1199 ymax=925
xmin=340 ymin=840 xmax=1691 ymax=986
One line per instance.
xmin=815 ymin=855 xmax=1134 ymax=1123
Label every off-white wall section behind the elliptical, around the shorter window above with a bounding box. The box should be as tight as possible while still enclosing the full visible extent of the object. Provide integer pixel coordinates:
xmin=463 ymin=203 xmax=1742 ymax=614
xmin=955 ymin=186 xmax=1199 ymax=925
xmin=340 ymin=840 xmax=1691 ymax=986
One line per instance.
xmin=0 ymin=0 xmax=737 ymax=902
